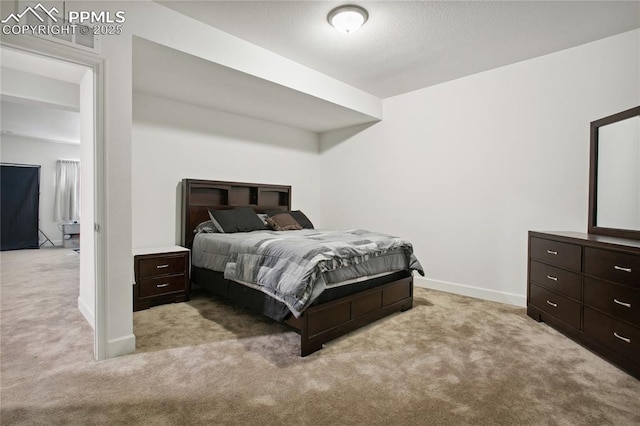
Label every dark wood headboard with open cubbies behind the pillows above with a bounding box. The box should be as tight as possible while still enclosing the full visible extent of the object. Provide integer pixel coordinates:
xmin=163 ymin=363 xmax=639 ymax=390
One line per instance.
xmin=181 ymin=179 xmax=291 ymax=248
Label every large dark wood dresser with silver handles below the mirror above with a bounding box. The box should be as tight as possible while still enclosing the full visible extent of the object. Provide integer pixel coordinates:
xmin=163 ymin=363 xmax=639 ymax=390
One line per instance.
xmin=527 ymin=231 xmax=640 ymax=378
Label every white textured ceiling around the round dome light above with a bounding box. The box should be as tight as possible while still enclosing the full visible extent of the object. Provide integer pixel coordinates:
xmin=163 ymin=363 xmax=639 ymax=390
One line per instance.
xmin=160 ymin=0 xmax=640 ymax=98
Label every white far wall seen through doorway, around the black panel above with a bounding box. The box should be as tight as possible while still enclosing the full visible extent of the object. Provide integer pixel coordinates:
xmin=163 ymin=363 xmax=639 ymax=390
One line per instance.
xmin=0 ymin=134 xmax=81 ymax=247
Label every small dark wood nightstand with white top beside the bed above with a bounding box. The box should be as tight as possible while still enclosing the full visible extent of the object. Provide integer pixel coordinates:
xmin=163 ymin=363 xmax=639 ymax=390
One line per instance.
xmin=133 ymin=246 xmax=190 ymax=311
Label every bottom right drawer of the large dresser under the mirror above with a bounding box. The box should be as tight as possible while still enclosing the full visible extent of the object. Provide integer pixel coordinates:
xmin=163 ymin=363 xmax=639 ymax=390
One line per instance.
xmin=583 ymin=307 xmax=640 ymax=362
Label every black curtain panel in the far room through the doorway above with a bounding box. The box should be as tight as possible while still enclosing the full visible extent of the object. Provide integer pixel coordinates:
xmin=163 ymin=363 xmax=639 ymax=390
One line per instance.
xmin=0 ymin=164 xmax=40 ymax=250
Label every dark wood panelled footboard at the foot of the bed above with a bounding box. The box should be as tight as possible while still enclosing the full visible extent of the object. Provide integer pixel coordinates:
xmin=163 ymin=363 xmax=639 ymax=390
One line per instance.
xmin=285 ymin=277 xmax=413 ymax=356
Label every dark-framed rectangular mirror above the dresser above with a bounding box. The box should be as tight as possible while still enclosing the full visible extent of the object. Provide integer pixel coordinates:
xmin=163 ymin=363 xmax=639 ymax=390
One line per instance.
xmin=589 ymin=107 xmax=640 ymax=239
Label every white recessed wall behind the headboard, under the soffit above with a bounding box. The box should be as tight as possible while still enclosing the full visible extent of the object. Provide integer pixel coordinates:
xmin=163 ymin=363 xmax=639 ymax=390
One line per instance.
xmin=132 ymin=93 xmax=322 ymax=248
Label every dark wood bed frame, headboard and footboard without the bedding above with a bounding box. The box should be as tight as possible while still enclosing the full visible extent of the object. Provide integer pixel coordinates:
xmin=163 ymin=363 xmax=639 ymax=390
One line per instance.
xmin=182 ymin=179 xmax=413 ymax=356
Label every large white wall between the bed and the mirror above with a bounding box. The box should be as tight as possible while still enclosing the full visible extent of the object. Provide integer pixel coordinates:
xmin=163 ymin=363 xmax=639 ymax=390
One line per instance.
xmin=321 ymin=30 xmax=640 ymax=305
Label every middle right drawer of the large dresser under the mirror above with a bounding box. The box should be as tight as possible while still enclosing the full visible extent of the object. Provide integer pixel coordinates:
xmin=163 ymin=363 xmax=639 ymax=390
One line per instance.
xmin=584 ymin=277 xmax=640 ymax=327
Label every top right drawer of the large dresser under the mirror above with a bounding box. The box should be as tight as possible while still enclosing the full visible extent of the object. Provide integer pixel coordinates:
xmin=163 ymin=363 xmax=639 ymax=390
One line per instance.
xmin=584 ymin=247 xmax=640 ymax=288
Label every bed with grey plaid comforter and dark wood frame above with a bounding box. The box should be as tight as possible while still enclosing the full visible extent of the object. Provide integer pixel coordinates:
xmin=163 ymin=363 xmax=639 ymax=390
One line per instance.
xmin=181 ymin=179 xmax=423 ymax=356
